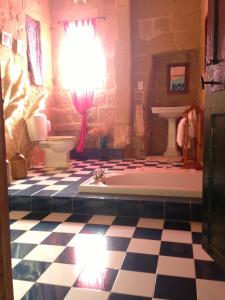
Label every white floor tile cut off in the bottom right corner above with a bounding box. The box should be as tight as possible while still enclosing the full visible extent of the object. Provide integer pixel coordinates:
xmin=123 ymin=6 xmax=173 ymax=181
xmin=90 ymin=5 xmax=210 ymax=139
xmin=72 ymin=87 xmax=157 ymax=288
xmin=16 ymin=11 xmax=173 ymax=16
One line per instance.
xmin=196 ymin=279 xmax=225 ymax=300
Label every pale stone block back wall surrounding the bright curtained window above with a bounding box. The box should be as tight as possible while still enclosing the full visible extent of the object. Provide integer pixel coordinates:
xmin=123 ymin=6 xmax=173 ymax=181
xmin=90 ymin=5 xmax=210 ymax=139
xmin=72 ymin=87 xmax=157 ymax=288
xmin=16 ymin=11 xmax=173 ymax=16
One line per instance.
xmin=50 ymin=0 xmax=131 ymax=147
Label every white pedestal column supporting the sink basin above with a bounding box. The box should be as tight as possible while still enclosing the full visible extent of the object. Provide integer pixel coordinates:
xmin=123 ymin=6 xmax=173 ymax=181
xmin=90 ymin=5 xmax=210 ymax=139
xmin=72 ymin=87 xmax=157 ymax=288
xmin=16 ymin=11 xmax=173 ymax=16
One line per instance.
xmin=163 ymin=119 xmax=180 ymax=156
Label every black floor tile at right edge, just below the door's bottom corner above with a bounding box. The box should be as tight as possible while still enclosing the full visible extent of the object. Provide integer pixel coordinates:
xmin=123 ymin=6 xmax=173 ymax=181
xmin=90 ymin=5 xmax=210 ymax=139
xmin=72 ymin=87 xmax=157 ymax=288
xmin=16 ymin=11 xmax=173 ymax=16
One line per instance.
xmin=195 ymin=260 xmax=225 ymax=281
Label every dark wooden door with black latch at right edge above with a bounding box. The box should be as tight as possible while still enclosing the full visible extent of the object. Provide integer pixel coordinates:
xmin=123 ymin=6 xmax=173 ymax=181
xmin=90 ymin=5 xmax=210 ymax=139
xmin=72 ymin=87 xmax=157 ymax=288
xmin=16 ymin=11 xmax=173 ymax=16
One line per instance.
xmin=202 ymin=0 xmax=225 ymax=269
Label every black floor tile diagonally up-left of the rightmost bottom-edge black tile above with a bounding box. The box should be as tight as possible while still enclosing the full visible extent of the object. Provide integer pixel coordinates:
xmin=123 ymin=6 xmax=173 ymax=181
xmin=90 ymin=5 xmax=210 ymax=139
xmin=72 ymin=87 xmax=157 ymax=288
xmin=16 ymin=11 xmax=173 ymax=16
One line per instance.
xmin=121 ymin=252 xmax=158 ymax=273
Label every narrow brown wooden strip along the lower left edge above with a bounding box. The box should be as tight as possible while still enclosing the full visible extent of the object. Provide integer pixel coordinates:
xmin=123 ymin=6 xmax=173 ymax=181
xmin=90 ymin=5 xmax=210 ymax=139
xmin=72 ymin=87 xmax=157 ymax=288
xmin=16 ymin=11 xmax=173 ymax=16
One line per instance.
xmin=0 ymin=69 xmax=13 ymax=300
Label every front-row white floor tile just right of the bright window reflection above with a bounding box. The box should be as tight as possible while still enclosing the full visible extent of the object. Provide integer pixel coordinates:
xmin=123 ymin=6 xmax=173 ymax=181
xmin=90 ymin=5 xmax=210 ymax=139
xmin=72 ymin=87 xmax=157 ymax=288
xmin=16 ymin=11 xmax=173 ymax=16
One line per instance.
xmin=112 ymin=270 xmax=156 ymax=297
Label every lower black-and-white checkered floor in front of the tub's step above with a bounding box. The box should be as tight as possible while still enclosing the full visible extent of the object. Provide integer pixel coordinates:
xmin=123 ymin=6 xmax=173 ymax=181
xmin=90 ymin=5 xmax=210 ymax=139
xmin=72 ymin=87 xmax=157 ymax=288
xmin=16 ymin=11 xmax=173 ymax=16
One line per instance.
xmin=10 ymin=211 xmax=225 ymax=300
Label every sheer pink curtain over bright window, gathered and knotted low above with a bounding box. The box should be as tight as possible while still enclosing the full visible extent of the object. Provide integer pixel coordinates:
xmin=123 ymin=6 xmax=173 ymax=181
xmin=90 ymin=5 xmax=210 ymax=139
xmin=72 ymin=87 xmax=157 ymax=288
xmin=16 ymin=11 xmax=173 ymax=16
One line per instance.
xmin=64 ymin=19 xmax=96 ymax=152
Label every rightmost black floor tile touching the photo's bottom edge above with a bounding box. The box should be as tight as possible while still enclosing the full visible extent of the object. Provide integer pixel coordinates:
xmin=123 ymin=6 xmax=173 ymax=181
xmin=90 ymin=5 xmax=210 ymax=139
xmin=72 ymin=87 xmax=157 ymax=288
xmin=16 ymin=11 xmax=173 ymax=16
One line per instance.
xmin=154 ymin=275 xmax=197 ymax=300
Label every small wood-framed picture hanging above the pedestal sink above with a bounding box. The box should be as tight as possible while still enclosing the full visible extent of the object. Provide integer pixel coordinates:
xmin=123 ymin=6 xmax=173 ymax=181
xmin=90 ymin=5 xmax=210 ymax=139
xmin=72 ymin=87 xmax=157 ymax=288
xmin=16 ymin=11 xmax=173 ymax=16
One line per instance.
xmin=167 ymin=63 xmax=189 ymax=94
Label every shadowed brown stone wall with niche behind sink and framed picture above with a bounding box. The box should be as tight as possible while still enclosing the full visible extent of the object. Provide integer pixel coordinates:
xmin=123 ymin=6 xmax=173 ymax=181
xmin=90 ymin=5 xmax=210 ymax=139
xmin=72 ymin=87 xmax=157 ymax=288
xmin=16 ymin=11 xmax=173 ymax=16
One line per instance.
xmin=131 ymin=0 xmax=203 ymax=156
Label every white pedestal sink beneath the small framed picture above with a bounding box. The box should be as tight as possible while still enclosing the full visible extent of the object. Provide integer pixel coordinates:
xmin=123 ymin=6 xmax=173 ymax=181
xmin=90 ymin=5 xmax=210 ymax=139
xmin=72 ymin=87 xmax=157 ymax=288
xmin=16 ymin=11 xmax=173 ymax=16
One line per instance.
xmin=152 ymin=106 xmax=189 ymax=156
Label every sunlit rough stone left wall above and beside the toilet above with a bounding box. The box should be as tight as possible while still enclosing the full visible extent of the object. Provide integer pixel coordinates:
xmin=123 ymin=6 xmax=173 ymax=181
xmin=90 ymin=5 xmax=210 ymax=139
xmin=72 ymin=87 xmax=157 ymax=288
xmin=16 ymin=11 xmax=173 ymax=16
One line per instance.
xmin=0 ymin=0 xmax=52 ymax=160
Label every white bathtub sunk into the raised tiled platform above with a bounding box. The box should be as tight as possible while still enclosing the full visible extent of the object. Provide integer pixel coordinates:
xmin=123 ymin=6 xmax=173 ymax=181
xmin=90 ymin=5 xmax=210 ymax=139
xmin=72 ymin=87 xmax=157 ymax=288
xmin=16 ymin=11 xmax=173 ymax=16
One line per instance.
xmin=79 ymin=169 xmax=202 ymax=198
